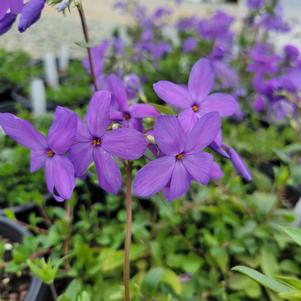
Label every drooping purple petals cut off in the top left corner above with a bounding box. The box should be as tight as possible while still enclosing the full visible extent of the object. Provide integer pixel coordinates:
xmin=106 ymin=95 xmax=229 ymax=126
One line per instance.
xmin=0 ymin=0 xmax=46 ymax=35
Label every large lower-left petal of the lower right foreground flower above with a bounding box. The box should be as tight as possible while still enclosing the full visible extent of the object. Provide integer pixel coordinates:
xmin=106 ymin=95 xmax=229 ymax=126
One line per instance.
xmin=134 ymin=156 xmax=175 ymax=197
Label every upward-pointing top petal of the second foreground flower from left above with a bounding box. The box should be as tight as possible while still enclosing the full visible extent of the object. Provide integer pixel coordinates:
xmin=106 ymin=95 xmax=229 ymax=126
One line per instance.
xmin=87 ymin=91 xmax=111 ymax=137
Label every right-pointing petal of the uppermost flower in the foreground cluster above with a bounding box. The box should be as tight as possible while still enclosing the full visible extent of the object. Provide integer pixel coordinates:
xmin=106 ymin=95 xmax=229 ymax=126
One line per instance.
xmin=201 ymin=93 xmax=239 ymax=116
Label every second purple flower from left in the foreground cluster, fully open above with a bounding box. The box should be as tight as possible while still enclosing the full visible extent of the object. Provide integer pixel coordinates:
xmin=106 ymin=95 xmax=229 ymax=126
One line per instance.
xmin=70 ymin=91 xmax=147 ymax=194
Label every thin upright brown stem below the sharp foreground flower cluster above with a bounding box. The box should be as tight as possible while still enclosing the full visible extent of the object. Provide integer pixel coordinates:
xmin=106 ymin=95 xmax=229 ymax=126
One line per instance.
xmin=123 ymin=162 xmax=132 ymax=301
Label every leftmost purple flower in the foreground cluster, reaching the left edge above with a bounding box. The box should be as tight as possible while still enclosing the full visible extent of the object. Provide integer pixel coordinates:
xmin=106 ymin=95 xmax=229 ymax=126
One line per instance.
xmin=0 ymin=107 xmax=77 ymax=201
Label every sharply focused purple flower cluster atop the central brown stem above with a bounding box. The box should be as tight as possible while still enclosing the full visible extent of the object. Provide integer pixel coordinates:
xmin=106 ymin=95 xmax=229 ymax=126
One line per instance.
xmin=0 ymin=58 xmax=251 ymax=201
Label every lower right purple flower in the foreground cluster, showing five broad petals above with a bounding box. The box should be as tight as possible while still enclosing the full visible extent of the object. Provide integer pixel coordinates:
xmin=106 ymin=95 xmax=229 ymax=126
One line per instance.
xmin=134 ymin=113 xmax=221 ymax=201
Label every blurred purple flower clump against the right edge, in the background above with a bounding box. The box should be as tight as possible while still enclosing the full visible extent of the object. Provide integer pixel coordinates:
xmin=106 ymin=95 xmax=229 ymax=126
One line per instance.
xmin=248 ymin=43 xmax=301 ymax=121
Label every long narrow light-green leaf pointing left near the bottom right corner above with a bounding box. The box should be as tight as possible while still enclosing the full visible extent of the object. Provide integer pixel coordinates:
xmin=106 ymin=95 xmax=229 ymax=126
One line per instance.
xmin=232 ymin=266 xmax=289 ymax=293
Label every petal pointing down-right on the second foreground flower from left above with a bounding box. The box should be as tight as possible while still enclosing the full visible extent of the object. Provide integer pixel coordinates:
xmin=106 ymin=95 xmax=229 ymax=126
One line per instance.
xmin=93 ymin=147 xmax=122 ymax=194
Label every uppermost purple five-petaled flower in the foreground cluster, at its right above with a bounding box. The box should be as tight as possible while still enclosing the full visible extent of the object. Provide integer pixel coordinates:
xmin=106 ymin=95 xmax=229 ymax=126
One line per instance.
xmin=154 ymin=58 xmax=238 ymax=131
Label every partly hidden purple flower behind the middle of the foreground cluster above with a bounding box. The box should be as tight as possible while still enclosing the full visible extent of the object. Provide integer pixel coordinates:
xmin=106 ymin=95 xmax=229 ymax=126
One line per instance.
xmin=108 ymin=74 xmax=160 ymax=131
